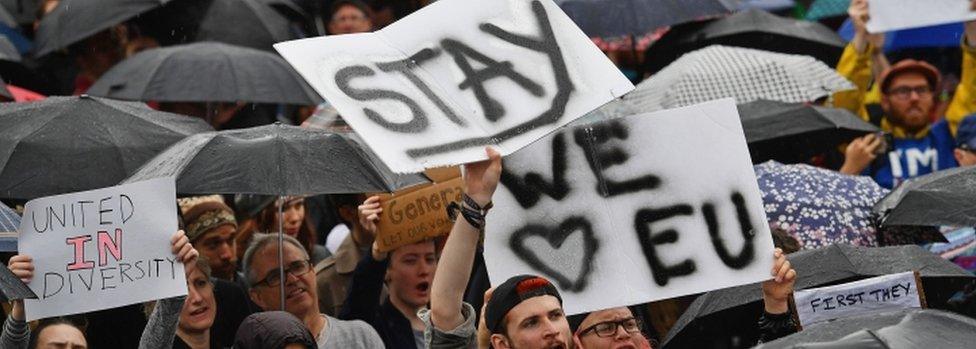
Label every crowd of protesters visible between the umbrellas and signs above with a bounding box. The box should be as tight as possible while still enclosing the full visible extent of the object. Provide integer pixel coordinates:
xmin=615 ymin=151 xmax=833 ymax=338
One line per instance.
xmin=0 ymin=0 xmax=976 ymax=349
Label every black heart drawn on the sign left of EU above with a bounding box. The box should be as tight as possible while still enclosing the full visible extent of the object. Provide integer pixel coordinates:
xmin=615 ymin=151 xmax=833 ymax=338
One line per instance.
xmin=508 ymin=216 xmax=600 ymax=292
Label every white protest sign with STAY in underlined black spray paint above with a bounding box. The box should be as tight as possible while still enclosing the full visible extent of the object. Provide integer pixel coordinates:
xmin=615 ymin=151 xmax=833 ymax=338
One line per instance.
xmin=275 ymin=0 xmax=634 ymax=173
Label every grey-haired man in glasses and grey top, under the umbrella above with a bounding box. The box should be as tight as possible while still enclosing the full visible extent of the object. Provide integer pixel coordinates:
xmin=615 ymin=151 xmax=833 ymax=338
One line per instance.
xmin=243 ymin=234 xmax=383 ymax=349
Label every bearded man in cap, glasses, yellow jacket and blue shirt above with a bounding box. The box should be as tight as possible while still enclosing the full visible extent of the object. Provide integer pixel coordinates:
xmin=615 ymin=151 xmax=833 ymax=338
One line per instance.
xmin=834 ymin=0 xmax=976 ymax=188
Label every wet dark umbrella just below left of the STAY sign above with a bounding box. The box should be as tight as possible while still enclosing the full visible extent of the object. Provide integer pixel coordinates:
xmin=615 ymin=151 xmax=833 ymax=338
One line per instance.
xmin=126 ymin=123 xmax=427 ymax=195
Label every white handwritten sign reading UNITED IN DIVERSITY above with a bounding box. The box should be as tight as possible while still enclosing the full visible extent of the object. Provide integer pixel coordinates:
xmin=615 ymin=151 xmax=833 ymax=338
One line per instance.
xmin=19 ymin=177 xmax=187 ymax=321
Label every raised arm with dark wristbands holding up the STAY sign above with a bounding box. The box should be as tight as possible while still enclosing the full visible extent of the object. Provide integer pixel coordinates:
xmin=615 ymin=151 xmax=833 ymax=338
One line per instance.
xmin=430 ymin=148 xmax=502 ymax=331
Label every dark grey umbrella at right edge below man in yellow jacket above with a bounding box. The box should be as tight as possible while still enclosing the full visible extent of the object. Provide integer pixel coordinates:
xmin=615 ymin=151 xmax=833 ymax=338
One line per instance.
xmin=874 ymin=167 xmax=976 ymax=227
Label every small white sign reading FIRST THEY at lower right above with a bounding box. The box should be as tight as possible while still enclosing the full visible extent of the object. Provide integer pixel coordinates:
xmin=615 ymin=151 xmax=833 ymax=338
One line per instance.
xmin=793 ymin=271 xmax=925 ymax=326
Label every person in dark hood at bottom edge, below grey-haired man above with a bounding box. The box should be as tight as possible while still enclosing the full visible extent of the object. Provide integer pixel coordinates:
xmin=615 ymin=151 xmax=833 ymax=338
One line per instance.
xmin=234 ymin=311 xmax=316 ymax=349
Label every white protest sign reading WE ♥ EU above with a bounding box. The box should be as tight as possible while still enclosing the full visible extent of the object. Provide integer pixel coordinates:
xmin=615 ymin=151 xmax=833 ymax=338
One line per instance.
xmin=485 ymin=99 xmax=773 ymax=314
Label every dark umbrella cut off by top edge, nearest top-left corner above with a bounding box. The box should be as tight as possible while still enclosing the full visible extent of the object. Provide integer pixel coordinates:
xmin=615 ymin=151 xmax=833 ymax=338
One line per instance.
xmin=34 ymin=0 xmax=170 ymax=57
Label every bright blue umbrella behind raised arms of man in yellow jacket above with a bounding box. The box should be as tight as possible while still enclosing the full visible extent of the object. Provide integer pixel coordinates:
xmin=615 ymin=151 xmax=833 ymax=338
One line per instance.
xmin=837 ymin=18 xmax=963 ymax=52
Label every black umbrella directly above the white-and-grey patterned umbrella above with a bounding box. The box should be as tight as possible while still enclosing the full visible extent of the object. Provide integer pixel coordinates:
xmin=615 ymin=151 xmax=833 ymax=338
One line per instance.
xmin=646 ymin=9 xmax=847 ymax=72
